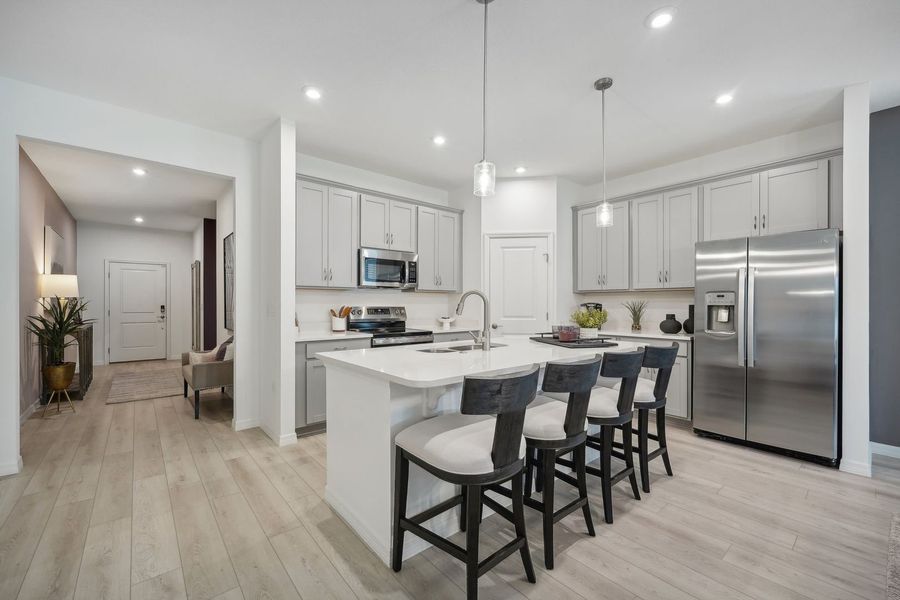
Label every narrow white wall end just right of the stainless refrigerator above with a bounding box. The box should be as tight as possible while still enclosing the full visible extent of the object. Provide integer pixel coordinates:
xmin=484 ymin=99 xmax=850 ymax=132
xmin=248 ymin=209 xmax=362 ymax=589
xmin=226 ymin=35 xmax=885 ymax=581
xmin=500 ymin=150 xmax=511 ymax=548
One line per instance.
xmin=841 ymin=83 xmax=872 ymax=477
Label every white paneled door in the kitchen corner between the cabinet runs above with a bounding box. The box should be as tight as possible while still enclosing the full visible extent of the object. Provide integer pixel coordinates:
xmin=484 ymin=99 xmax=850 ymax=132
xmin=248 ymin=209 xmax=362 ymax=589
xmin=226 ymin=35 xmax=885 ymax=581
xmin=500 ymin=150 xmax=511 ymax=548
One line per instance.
xmin=487 ymin=237 xmax=550 ymax=334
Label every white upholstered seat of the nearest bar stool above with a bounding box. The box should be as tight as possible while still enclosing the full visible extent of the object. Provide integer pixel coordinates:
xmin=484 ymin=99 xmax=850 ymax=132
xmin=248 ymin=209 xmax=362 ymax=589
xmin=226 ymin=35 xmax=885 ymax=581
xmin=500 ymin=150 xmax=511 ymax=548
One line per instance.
xmin=394 ymin=413 xmax=525 ymax=475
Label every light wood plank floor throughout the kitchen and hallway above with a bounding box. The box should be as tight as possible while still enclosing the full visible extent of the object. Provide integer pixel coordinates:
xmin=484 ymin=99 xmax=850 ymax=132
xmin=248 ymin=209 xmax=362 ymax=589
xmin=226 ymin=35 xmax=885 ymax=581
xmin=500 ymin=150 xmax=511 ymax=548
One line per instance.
xmin=0 ymin=363 xmax=900 ymax=600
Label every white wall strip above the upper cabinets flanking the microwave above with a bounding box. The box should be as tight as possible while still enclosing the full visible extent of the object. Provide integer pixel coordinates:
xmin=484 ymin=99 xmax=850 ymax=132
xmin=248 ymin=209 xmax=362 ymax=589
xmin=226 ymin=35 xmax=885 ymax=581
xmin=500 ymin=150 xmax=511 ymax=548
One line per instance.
xmin=297 ymin=153 xmax=448 ymax=206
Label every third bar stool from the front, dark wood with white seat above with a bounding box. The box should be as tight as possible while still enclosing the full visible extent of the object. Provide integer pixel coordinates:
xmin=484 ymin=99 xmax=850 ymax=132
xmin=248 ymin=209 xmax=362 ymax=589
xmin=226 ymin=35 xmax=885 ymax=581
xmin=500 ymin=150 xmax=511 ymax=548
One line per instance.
xmin=557 ymin=350 xmax=644 ymax=523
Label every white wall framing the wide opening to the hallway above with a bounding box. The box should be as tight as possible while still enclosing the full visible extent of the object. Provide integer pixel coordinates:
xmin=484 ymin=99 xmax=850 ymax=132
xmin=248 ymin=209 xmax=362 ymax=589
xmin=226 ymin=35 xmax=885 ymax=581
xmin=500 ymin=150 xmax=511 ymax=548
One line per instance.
xmin=0 ymin=78 xmax=264 ymax=475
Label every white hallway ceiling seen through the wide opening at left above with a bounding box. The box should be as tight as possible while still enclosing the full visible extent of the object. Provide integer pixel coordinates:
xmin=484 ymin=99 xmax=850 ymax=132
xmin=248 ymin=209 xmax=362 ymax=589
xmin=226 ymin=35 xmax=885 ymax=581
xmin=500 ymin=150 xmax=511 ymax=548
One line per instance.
xmin=20 ymin=140 xmax=231 ymax=231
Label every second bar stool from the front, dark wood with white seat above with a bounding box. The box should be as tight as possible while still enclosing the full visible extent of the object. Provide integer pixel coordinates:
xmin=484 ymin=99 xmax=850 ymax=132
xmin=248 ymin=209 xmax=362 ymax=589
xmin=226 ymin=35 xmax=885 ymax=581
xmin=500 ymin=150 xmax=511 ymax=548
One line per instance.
xmin=492 ymin=356 xmax=601 ymax=569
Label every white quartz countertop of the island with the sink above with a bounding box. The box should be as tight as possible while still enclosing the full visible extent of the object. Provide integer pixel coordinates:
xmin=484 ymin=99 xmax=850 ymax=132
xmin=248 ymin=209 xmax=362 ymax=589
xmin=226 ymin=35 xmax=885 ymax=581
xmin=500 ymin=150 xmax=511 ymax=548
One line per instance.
xmin=316 ymin=335 xmax=639 ymax=388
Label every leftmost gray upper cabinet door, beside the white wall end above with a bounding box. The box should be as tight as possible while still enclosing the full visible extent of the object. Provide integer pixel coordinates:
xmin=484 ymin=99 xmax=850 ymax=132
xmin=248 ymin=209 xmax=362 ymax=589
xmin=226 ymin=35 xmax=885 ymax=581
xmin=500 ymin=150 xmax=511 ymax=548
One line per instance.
xmin=296 ymin=181 xmax=328 ymax=287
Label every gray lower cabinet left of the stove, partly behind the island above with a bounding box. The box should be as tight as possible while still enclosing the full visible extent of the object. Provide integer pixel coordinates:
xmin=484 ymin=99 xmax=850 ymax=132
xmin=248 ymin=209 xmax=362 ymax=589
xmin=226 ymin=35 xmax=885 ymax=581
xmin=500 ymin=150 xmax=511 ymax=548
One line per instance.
xmin=294 ymin=338 xmax=371 ymax=432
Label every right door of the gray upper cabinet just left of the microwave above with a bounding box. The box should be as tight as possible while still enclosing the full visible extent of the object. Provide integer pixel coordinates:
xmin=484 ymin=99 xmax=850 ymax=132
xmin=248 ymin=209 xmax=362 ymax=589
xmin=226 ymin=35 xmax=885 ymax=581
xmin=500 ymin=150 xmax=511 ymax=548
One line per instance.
xmin=328 ymin=188 xmax=359 ymax=288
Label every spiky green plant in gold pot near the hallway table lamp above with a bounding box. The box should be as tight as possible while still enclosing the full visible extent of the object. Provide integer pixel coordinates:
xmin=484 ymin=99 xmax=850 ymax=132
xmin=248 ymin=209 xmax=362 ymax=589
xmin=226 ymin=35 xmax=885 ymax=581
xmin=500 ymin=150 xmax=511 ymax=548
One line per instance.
xmin=25 ymin=297 xmax=93 ymax=398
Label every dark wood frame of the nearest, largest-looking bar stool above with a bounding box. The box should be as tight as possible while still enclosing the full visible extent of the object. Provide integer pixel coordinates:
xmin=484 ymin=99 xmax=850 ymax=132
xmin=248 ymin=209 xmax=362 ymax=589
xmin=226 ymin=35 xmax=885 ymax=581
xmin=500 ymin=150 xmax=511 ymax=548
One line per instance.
xmin=391 ymin=366 xmax=540 ymax=600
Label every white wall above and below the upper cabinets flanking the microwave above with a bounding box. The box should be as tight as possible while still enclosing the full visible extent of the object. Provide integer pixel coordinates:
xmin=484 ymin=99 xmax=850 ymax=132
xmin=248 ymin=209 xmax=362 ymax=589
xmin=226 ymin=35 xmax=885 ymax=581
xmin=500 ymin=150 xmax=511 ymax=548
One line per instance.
xmin=292 ymin=154 xmax=460 ymax=330
